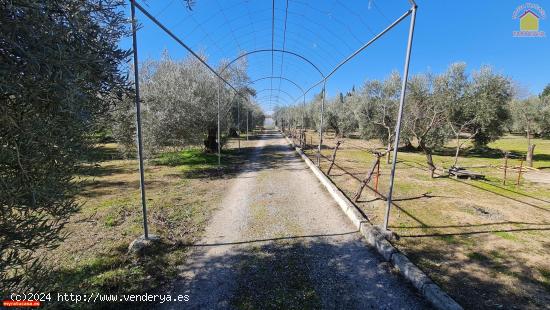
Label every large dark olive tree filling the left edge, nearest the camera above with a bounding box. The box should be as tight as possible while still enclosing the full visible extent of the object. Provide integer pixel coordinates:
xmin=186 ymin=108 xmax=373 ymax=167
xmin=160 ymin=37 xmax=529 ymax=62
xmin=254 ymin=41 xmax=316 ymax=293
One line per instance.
xmin=0 ymin=0 xmax=130 ymax=292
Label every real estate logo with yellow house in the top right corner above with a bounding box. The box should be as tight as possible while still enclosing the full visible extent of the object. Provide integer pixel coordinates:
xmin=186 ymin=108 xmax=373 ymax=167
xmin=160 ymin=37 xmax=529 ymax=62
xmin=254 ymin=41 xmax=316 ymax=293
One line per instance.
xmin=512 ymin=2 xmax=546 ymax=37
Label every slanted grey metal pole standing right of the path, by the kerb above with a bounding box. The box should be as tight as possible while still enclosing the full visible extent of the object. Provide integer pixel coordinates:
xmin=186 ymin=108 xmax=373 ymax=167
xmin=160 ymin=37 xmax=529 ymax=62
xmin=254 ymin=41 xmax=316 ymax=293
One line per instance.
xmin=384 ymin=5 xmax=417 ymax=230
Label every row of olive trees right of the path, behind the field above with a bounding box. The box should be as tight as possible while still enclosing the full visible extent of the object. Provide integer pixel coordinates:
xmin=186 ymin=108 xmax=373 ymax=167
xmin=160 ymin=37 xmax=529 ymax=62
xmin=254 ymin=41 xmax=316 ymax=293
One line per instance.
xmin=274 ymin=63 xmax=550 ymax=176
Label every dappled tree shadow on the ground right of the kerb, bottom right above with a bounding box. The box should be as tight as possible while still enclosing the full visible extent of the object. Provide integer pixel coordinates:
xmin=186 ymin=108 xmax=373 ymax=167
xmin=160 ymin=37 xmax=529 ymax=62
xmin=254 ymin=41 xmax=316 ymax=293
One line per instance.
xmin=407 ymin=236 xmax=550 ymax=309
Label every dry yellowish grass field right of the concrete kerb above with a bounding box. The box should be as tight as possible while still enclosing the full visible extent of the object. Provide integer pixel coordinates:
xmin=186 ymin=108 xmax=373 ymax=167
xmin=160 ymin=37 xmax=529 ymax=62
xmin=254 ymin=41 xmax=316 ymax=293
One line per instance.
xmin=298 ymin=132 xmax=550 ymax=309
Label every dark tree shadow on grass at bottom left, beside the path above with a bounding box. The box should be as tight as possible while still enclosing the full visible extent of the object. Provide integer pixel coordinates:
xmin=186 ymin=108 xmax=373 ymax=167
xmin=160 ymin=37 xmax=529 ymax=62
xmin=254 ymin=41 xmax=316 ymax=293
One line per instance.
xmin=35 ymin=241 xmax=181 ymax=309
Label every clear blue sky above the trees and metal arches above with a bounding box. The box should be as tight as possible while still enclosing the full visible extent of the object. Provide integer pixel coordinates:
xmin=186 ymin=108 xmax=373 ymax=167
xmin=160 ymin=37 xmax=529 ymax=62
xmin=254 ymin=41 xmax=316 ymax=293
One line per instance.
xmin=121 ymin=0 xmax=550 ymax=111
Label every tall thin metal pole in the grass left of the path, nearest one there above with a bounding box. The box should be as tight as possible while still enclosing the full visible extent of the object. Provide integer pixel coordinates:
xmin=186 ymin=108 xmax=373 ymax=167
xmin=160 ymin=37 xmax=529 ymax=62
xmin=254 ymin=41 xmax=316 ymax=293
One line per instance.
xmin=130 ymin=0 xmax=149 ymax=239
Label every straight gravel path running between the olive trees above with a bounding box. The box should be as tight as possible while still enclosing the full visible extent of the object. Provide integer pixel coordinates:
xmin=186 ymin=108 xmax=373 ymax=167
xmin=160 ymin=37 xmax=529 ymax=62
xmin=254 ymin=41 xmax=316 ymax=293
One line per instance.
xmin=164 ymin=131 xmax=428 ymax=309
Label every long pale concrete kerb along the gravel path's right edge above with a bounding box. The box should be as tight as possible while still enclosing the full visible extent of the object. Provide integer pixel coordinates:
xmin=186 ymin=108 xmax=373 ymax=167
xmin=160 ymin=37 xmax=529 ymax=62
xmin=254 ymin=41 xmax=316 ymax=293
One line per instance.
xmin=283 ymin=133 xmax=462 ymax=310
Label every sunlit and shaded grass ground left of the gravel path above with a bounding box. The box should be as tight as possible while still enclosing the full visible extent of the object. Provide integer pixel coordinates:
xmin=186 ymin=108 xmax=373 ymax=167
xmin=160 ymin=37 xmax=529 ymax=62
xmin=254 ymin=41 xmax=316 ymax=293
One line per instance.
xmin=33 ymin=142 xmax=246 ymax=309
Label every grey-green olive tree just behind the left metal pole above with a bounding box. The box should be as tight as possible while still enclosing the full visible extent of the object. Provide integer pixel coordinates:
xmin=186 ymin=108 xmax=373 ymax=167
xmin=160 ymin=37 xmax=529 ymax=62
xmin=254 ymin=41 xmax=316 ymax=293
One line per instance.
xmin=113 ymin=51 xmax=261 ymax=156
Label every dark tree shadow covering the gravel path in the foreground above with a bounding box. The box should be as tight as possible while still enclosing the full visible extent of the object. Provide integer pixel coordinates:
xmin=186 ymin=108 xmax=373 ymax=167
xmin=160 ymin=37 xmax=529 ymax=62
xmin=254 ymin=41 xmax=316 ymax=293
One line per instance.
xmin=160 ymin=236 xmax=430 ymax=309
